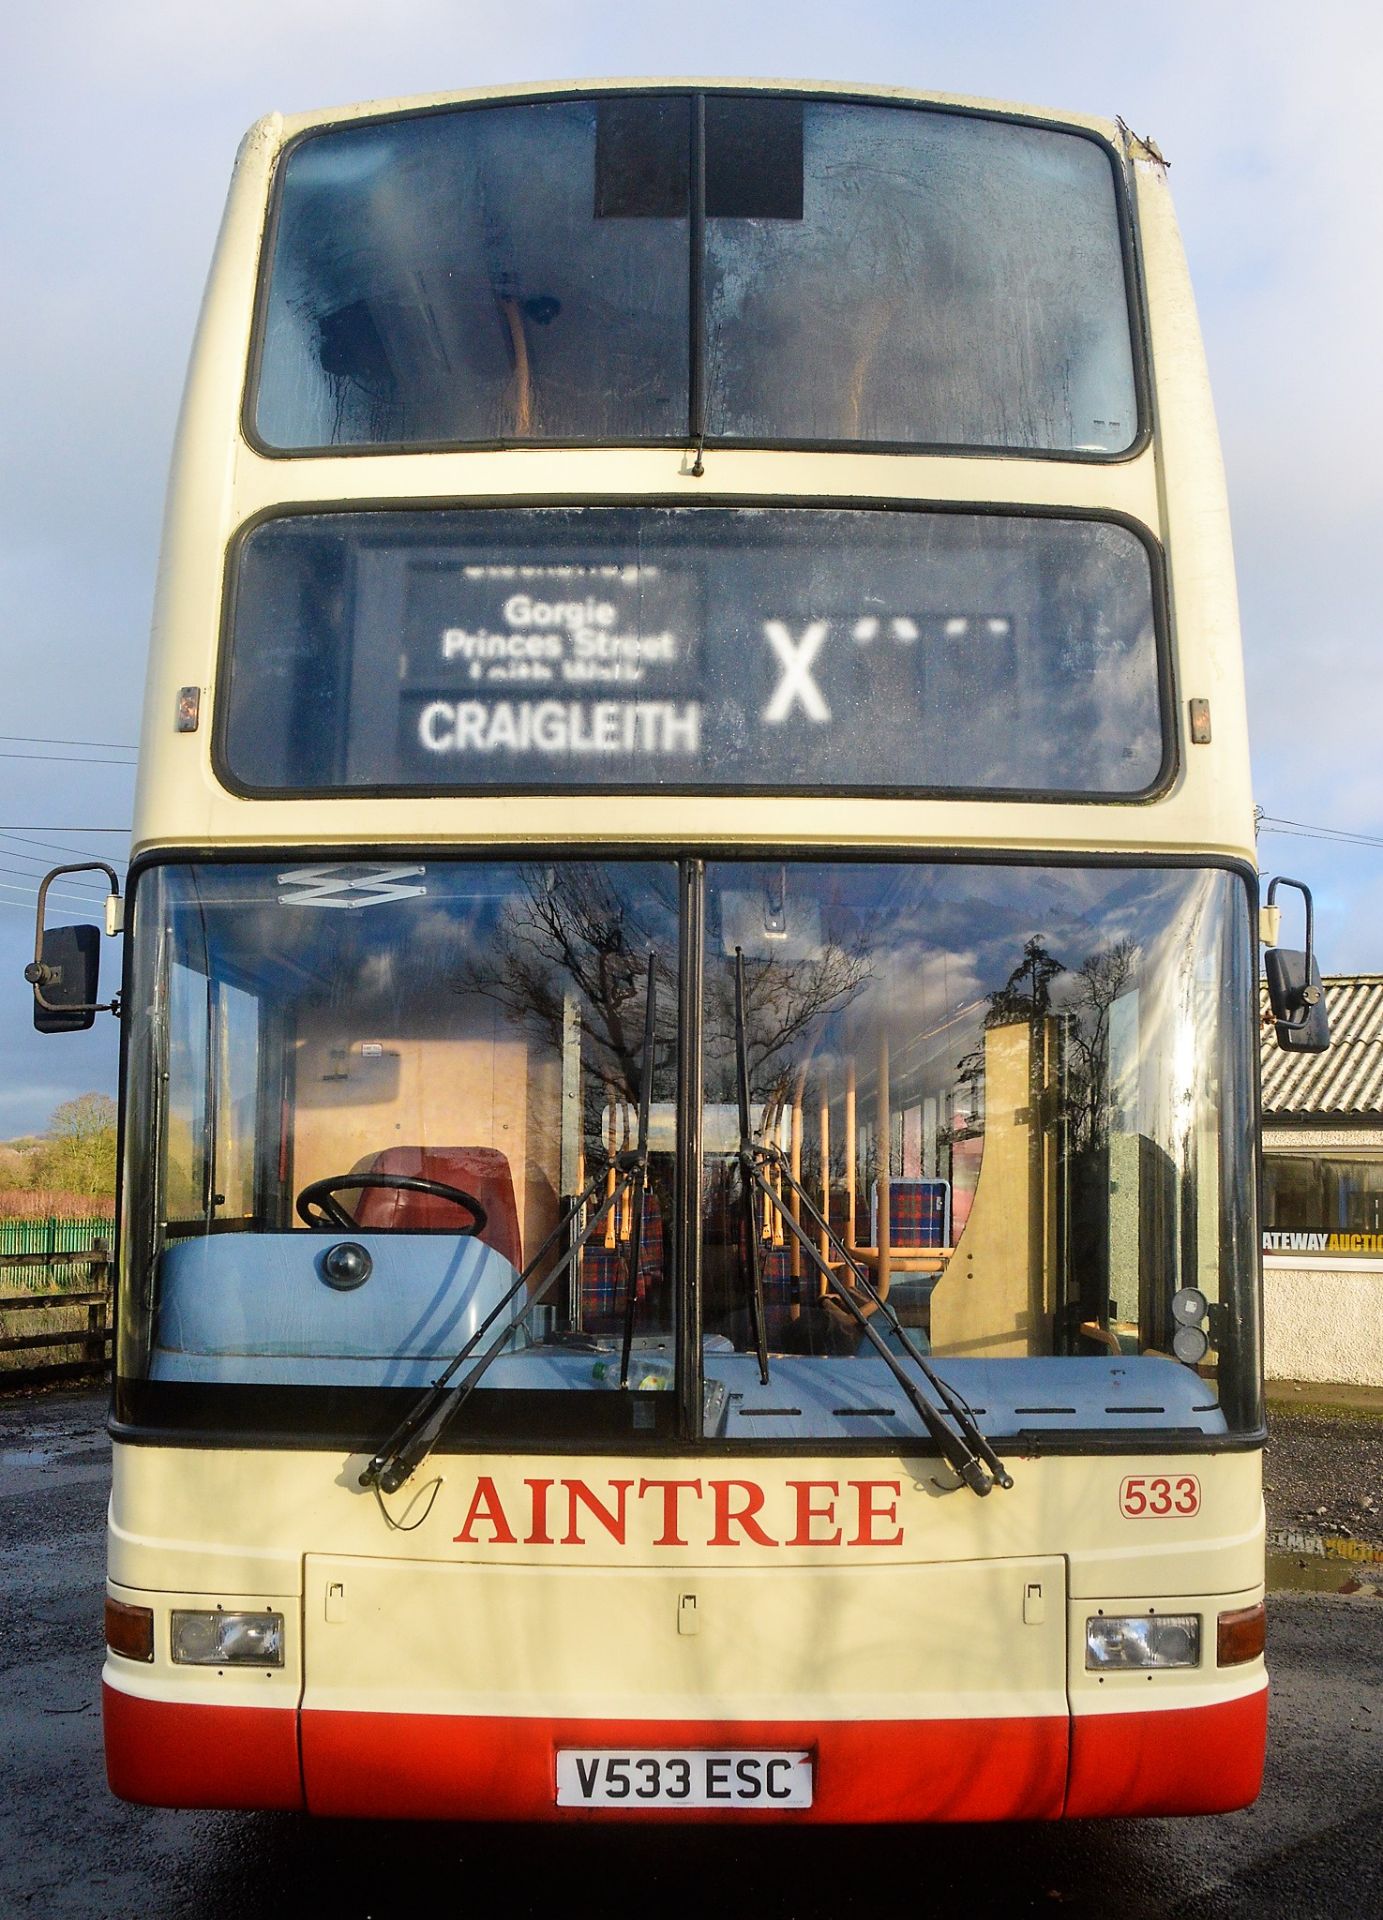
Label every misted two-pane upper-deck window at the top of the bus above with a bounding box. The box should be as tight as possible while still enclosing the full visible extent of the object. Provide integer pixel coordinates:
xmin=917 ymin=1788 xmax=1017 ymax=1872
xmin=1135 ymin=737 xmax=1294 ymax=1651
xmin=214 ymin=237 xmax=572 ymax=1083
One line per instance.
xmin=248 ymin=94 xmax=1139 ymax=457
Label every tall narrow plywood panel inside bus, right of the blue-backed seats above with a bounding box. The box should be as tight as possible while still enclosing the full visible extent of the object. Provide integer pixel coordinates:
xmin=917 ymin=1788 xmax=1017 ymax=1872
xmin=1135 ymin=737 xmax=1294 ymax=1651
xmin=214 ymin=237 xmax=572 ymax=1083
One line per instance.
xmin=932 ymin=1020 xmax=1051 ymax=1357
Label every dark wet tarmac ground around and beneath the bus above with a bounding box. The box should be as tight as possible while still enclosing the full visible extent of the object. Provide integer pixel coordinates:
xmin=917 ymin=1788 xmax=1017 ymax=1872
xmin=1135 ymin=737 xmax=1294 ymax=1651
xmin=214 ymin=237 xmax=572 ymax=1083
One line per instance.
xmin=0 ymin=1388 xmax=1383 ymax=1920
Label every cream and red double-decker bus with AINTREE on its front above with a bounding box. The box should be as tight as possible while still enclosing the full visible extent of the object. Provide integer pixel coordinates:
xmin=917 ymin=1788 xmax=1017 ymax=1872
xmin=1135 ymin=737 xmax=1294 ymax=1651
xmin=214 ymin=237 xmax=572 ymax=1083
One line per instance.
xmin=70 ymin=83 xmax=1266 ymax=1822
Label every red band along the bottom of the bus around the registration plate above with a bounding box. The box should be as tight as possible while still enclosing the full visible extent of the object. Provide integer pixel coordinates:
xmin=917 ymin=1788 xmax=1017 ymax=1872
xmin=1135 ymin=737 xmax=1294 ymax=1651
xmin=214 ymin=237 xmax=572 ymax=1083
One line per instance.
xmin=104 ymin=1686 xmax=1268 ymax=1822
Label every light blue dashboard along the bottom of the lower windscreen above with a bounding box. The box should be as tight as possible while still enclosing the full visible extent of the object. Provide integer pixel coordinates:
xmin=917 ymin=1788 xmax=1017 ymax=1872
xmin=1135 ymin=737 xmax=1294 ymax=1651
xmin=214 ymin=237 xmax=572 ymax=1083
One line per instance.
xmin=152 ymin=1233 xmax=1227 ymax=1448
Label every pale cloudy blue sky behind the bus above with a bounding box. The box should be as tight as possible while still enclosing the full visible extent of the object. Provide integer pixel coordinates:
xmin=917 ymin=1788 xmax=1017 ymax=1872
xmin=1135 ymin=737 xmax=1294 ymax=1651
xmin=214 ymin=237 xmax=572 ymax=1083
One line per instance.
xmin=0 ymin=0 xmax=1383 ymax=1139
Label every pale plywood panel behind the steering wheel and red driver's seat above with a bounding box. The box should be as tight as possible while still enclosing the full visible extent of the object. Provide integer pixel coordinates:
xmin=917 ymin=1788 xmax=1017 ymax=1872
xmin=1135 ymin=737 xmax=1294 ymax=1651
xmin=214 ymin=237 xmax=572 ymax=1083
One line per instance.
xmin=294 ymin=1000 xmax=561 ymax=1248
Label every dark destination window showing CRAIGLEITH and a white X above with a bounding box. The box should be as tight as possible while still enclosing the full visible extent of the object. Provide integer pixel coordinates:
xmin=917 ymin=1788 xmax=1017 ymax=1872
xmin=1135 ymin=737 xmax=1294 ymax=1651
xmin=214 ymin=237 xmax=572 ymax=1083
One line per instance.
xmin=217 ymin=507 xmax=1164 ymax=797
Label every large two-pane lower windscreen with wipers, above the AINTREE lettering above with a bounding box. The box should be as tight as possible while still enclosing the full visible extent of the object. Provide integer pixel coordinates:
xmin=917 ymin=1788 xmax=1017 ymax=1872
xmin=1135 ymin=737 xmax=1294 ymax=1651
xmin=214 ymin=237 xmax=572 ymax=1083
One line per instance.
xmin=119 ymin=849 xmax=1260 ymax=1443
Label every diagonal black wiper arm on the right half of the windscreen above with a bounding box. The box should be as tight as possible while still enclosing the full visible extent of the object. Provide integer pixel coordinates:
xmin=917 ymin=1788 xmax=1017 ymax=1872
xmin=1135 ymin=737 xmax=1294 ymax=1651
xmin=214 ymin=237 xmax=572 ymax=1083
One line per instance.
xmin=753 ymin=1146 xmax=1012 ymax=1496
